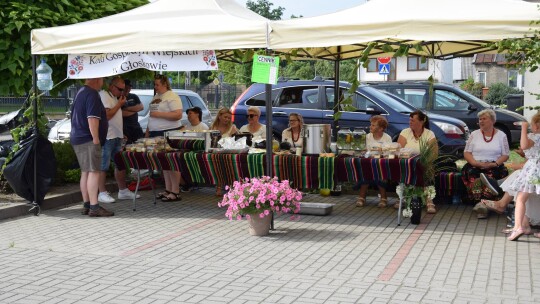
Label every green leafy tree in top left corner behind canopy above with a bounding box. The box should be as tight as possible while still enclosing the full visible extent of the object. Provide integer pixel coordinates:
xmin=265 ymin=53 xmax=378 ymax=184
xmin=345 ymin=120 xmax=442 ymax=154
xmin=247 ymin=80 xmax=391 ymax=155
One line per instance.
xmin=0 ymin=0 xmax=148 ymax=95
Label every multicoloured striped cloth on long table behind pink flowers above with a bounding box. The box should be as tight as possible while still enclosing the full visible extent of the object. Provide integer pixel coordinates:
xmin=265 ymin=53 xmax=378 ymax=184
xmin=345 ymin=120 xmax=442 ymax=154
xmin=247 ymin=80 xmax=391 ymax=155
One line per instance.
xmin=114 ymin=151 xmax=334 ymax=189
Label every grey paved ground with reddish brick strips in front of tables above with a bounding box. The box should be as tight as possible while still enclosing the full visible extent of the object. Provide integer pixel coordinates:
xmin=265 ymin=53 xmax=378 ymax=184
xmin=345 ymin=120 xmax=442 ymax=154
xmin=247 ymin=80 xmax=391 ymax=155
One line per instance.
xmin=0 ymin=188 xmax=540 ymax=303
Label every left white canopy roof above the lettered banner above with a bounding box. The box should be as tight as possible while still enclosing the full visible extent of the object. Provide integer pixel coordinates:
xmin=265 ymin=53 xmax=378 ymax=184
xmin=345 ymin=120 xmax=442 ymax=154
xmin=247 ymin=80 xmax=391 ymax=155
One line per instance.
xmin=31 ymin=0 xmax=270 ymax=54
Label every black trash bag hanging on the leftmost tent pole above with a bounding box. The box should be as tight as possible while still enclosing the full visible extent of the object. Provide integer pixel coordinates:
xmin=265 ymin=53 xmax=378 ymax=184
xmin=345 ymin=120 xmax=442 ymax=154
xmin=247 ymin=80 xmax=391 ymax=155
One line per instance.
xmin=4 ymin=132 xmax=56 ymax=205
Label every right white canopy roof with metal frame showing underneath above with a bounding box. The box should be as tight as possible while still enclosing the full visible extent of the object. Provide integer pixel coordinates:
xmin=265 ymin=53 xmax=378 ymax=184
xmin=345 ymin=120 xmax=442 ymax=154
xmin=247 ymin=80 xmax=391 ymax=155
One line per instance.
xmin=270 ymin=0 xmax=540 ymax=60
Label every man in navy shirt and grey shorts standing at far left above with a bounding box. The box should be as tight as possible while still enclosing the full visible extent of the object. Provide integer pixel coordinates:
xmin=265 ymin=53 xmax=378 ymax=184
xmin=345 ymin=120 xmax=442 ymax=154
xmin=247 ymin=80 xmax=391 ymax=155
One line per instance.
xmin=69 ymin=78 xmax=114 ymax=217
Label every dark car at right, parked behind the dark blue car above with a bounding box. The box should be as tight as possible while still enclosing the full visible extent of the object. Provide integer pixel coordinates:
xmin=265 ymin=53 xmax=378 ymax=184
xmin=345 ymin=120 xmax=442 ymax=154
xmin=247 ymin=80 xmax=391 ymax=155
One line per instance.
xmin=368 ymin=81 xmax=525 ymax=143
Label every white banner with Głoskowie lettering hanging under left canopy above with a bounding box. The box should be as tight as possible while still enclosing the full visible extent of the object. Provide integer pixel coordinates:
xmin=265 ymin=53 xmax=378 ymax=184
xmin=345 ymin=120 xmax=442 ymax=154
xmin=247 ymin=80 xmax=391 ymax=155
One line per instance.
xmin=67 ymin=50 xmax=218 ymax=79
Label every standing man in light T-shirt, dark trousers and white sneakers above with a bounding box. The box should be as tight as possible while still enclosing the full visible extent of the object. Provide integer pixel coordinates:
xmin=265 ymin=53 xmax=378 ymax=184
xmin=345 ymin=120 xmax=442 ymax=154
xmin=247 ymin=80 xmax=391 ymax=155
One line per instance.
xmin=98 ymin=76 xmax=140 ymax=203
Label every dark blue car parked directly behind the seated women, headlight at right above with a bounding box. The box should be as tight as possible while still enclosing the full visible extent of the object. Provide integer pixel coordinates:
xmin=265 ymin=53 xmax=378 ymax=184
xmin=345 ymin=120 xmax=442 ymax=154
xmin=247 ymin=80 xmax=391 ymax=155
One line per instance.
xmin=231 ymin=78 xmax=469 ymax=156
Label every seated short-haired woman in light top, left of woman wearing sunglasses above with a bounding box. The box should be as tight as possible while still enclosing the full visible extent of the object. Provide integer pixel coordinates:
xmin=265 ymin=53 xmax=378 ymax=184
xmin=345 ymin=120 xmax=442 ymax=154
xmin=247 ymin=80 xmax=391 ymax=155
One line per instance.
xmin=356 ymin=115 xmax=392 ymax=208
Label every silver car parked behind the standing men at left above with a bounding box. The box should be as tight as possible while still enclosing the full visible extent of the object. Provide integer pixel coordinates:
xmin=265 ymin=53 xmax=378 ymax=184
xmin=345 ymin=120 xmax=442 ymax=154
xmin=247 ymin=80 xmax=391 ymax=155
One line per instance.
xmin=48 ymin=89 xmax=212 ymax=142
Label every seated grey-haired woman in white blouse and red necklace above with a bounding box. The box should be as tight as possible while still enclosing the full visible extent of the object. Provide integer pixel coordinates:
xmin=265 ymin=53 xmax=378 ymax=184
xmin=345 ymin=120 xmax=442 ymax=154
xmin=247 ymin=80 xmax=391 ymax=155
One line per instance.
xmin=461 ymin=109 xmax=510 ymax=211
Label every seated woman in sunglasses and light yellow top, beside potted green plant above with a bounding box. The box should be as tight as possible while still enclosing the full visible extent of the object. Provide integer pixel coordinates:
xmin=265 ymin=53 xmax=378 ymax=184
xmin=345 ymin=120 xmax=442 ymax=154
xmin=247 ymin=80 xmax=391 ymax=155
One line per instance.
xmin=394 ymin=110 xmax=439 ymax=214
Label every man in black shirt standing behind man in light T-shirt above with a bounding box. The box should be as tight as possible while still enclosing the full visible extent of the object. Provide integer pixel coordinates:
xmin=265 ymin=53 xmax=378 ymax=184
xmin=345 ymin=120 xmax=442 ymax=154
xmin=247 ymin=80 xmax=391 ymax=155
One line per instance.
xmin=122 ymin=79 xmax=144 ymax=144
